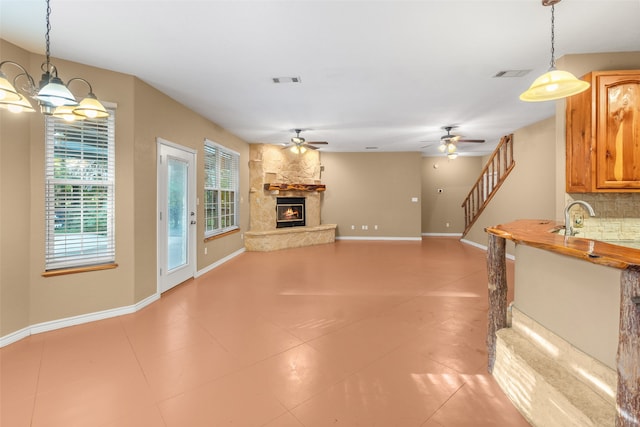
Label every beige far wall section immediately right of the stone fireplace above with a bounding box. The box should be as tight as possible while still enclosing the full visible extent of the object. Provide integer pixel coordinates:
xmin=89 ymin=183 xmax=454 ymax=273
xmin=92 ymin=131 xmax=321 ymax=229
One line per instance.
xmin=320 ymin=152 xmax=422 ymax=238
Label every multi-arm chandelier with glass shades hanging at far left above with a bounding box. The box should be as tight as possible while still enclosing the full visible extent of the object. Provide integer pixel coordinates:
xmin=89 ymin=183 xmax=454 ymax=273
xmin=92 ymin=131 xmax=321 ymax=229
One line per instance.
xmin=0 ymin=0 xmax=109 ymax=121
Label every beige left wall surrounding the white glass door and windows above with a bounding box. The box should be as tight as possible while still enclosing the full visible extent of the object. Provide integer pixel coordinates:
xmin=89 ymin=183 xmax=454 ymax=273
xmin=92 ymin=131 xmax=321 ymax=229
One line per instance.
xmin=0 ymin=40 xmax=249 ymax=337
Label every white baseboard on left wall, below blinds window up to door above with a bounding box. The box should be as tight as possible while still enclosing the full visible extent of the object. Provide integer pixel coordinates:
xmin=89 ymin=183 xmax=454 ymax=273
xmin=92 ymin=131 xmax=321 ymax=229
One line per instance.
xmin=0 ymin=293 xmax=160 ymax=348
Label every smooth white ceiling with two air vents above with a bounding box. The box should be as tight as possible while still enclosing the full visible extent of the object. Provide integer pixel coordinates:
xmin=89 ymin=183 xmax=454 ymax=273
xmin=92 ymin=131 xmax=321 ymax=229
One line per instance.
xmin=0 ymin=0 xmax=640 ymax=155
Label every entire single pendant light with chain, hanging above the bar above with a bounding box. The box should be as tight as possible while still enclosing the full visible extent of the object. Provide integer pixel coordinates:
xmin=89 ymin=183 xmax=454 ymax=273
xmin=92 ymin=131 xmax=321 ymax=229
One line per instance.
xmin=520 ymin=0 xmax=591 ymax=102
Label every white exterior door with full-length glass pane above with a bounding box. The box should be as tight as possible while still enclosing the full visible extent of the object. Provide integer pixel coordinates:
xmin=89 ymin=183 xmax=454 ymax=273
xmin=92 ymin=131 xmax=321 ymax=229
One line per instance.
xmin=157 ymin=138 xmax=196 ymax=293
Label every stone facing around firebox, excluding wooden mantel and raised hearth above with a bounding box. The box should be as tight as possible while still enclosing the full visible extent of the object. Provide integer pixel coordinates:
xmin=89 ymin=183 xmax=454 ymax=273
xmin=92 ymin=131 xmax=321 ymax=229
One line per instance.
xmin=249 ymin=144 xmax=322 ymax=231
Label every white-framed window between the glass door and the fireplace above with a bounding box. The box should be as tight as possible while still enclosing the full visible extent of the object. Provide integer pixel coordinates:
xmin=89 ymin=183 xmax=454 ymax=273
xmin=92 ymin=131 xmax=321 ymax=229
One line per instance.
xmin=204 ymin=141 xmax=240 ymax=237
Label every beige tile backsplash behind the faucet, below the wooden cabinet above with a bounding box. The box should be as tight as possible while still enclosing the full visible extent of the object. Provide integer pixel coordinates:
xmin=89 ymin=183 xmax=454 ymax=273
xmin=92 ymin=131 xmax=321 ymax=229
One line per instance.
xmin=570 ymin=193 xmax=640 ymax=240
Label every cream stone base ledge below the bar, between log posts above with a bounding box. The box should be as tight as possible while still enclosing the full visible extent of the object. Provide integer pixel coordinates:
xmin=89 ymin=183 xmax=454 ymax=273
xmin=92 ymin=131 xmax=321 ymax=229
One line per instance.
xmin=493 ymin=307 xmax=616 ymax=427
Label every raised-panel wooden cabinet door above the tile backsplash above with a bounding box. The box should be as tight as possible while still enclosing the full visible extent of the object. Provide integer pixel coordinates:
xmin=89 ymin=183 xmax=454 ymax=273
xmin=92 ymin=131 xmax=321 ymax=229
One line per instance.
xmin=596 ymin=71 xmax=640 ymax=189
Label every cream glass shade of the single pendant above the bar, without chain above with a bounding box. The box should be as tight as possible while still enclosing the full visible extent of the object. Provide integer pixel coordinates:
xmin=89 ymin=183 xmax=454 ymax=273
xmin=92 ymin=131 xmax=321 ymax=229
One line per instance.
xmin=520 ymin=70 xmax=591 ymax=102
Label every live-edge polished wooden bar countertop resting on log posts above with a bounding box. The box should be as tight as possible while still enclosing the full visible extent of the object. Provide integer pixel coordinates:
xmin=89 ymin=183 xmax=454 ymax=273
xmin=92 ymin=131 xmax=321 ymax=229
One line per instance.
xmin=485 ymin=219 xmax=640 ymax=270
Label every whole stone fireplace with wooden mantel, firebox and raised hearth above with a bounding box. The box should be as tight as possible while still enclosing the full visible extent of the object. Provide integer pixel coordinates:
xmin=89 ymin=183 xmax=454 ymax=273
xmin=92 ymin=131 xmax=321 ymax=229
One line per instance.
xmin=244 ymin=144 xmax=336 ymax=251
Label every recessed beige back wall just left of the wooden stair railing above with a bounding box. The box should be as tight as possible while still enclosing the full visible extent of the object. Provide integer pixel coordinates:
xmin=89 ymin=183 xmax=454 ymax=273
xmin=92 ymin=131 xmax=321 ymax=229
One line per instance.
xmin=422 ymin=155 xmax=485 ymax=234
